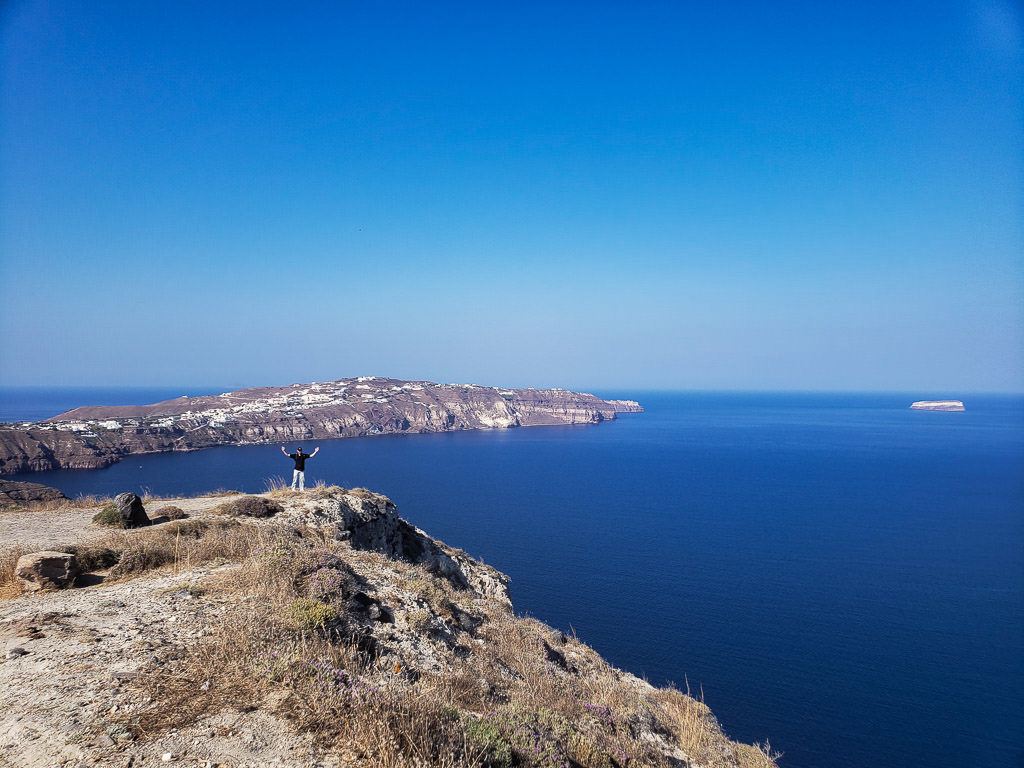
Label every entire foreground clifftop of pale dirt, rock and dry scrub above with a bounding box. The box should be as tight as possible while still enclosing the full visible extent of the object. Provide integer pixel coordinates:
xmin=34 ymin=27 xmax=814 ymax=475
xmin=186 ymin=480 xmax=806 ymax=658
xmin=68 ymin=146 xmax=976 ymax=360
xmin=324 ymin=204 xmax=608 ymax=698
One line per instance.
xmin=0 ymin=487 xmax=774 ymax=768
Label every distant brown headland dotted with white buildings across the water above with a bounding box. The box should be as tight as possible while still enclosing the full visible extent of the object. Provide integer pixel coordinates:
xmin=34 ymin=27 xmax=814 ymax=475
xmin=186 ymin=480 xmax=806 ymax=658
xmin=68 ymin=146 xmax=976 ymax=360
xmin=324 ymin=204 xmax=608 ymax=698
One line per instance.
xmin=0 ymin=377 xmax=643 ymax=474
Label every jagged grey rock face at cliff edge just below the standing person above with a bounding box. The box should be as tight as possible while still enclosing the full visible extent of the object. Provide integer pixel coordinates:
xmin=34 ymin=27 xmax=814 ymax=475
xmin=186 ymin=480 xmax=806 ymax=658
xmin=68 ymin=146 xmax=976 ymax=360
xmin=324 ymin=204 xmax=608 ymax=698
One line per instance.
xmin=291 ymin=490 xmax=511 ymax=605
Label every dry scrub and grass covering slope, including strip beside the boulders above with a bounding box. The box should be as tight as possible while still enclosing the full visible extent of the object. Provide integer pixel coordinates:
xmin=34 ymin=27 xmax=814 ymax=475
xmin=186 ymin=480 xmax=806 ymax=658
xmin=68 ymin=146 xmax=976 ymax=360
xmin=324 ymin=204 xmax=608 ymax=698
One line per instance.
xmin=0 ymin=486 xmax=775 ymax=768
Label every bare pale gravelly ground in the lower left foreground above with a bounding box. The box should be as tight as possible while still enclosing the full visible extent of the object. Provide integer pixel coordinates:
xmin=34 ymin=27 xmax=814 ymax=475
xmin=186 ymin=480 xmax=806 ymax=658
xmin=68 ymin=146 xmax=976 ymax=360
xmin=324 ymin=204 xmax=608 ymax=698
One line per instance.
xmin=0 ymin=566 xmax=337 ymax=768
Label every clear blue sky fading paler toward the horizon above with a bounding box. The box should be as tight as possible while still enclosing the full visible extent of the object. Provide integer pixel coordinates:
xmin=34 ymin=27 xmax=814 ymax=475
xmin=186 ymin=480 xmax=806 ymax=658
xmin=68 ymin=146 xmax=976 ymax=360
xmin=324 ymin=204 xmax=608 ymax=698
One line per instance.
xmin=0 ymin=0 xmax=1024 ymax=396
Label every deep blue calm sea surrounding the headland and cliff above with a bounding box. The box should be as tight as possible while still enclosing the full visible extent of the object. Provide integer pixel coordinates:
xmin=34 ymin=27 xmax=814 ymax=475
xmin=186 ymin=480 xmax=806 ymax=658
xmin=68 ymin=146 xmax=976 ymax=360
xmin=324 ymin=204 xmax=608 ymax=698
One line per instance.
xmin=0 ymin=388 xmax=1024 ymax=768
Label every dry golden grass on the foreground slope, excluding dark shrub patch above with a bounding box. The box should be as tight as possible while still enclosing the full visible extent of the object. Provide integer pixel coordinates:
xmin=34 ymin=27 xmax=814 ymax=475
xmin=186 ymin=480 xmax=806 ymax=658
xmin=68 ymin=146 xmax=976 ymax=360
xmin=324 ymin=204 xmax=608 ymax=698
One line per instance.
xmin=105 ymin=526 xmax=774 ymax=768
